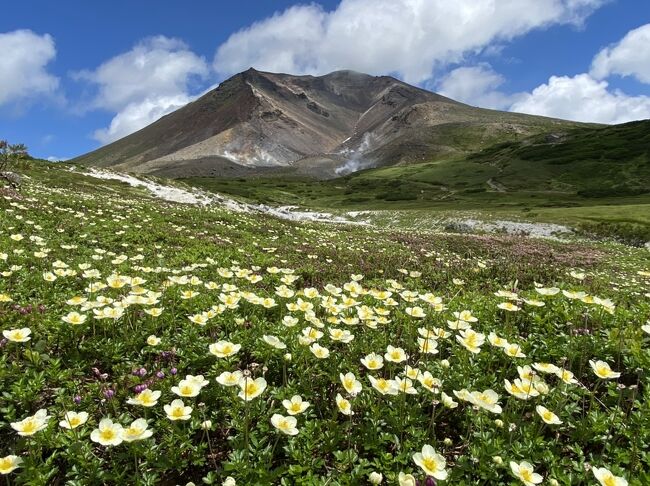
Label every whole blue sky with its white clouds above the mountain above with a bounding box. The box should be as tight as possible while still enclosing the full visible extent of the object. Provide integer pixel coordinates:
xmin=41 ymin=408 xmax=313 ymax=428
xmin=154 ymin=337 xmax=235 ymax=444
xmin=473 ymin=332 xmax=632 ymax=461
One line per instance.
xmin=0 ymin=0 xmax=650 ymax=158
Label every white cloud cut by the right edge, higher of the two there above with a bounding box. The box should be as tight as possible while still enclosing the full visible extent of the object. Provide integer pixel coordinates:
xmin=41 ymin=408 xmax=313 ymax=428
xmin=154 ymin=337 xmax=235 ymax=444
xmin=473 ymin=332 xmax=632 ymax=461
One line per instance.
xmin=591 ymin=24 xmax=650 ymax=84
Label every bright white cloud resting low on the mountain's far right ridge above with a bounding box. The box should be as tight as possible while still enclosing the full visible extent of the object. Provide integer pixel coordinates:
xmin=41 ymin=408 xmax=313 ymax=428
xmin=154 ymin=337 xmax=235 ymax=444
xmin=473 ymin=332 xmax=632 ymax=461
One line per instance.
xmin=510 ymin=73 xmax=650 ymax=123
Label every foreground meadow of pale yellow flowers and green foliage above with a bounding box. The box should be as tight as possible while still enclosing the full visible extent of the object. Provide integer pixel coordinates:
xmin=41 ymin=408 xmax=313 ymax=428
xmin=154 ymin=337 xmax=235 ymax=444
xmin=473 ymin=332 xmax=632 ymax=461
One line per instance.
xmin=0 ymin=165 xmax=650 ymax=486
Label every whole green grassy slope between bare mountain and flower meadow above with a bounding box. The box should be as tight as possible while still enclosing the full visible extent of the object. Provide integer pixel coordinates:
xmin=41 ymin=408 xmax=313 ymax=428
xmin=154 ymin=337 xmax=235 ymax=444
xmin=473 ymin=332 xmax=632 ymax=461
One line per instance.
xmin=181 ymin=121 xmax=650 ymax=239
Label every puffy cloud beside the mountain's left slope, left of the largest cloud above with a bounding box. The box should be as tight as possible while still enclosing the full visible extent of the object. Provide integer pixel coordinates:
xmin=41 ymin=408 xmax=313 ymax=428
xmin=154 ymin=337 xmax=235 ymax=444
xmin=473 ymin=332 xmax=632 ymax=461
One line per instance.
xmin=75 ymin=36 xmax=209 ymax=144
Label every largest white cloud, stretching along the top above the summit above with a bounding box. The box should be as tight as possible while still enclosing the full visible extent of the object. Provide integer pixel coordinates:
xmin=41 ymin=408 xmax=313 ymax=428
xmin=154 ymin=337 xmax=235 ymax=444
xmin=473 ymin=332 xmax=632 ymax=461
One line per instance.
xmin=214 ymin=0 xmax=606 ymax=83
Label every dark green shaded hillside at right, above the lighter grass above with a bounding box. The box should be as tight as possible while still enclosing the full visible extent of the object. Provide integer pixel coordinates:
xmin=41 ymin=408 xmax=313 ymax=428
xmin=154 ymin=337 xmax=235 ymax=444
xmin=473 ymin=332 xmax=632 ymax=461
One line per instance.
xmin=467 ymin=121 xmax=650 ymax=198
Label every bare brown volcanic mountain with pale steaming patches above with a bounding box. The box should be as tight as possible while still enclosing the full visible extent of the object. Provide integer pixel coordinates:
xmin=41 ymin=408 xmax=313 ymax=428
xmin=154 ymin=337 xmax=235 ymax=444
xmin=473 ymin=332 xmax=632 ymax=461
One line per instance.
xmin=72 ymin=69 xmax=575 ymax=178
